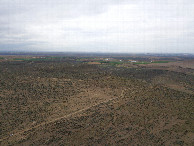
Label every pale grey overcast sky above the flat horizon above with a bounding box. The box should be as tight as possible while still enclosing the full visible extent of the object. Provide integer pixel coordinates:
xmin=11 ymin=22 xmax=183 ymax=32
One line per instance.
xmin=0 ymin=0 xmax=194 ymax=53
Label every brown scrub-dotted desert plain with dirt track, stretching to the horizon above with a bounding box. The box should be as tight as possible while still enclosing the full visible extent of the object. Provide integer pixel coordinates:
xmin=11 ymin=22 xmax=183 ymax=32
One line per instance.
xmin=0 ymin=54 xmax=194 ymax=145
